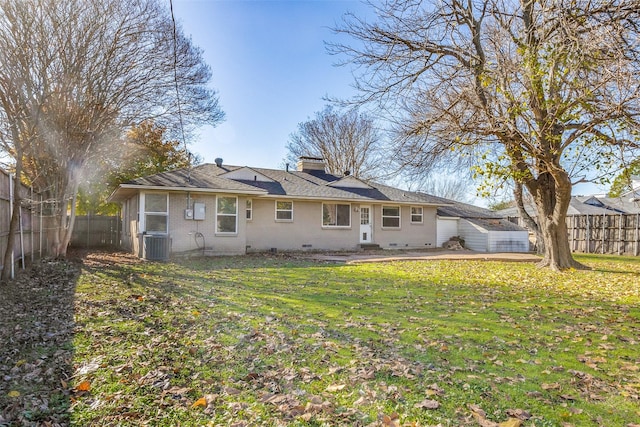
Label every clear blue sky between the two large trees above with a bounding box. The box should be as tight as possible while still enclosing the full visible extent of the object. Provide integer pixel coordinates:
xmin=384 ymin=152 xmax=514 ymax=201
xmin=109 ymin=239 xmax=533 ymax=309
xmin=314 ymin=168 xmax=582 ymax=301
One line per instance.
xmin=173 ymin=0 xmax=367 ymax=168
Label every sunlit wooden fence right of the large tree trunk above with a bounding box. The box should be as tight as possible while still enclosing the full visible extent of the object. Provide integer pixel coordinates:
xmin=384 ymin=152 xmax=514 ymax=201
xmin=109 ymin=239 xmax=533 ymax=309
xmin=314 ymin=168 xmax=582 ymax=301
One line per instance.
xmin=567 ymin=214 xmax=640 ymax=256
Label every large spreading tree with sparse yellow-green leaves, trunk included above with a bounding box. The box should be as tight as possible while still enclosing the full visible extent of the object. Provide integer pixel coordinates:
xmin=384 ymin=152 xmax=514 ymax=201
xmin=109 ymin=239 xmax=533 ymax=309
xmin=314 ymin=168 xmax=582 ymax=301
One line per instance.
xmin=330 ymin=0 xmax=640 ymax=269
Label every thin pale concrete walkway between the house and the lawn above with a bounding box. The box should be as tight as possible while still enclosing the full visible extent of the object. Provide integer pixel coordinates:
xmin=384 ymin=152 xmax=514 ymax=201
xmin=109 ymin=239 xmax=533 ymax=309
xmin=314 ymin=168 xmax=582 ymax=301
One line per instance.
xmin=310 ymin=249 xmax=541 ymax=264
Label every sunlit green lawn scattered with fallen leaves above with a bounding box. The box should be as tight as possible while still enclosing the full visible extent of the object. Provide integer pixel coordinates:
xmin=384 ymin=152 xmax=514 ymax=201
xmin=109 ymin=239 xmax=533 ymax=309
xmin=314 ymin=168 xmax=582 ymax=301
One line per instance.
xmin=0 ymin=254 xmax=640 ymax=427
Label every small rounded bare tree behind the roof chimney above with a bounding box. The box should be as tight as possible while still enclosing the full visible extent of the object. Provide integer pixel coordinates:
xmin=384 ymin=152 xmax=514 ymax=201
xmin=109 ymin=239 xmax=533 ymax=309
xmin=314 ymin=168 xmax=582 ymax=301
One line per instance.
xmin=287 ymin=106 xmax=385 ymax=179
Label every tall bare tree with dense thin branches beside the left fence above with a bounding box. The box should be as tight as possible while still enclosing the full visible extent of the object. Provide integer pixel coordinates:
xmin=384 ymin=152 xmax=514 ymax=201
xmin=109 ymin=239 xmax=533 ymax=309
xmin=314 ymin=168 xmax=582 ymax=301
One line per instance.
xmin=0 ymin=0 xmax=224 ymax=270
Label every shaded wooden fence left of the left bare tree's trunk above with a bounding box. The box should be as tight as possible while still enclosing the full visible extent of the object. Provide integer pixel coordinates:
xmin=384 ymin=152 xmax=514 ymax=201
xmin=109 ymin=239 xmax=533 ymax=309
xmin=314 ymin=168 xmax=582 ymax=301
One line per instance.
xmin=0 ymin=169 xmax=43 ymax=277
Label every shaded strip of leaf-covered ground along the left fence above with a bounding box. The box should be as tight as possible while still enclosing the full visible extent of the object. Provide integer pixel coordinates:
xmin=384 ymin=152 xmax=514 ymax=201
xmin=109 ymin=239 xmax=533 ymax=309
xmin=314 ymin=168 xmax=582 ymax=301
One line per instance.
xmin=0 ymin=259 xmax=80 ymax=425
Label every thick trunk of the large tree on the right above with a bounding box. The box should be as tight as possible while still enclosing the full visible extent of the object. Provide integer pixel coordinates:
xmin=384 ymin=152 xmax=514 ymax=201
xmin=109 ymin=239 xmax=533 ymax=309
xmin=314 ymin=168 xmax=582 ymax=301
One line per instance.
xmin=527 ymin=170 xmax=587 ymax=270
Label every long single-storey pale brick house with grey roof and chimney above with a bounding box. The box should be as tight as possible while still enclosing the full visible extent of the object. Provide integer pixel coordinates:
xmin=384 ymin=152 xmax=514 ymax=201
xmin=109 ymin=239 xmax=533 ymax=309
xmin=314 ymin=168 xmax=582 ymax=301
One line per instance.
xmin=110 ymin=157 xmax=458 ymax=259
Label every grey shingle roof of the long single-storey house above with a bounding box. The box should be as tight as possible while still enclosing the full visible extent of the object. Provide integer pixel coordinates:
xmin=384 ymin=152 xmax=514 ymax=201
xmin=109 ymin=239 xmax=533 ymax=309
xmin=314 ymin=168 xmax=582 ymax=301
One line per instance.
xmin=111 ymin=163 xmax=451 ymax=206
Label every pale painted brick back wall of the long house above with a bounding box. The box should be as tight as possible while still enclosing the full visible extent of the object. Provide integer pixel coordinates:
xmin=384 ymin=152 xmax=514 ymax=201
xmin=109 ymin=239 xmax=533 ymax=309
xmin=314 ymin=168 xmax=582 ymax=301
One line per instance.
xmin=123 ymin=192 xmax=437 ymax=256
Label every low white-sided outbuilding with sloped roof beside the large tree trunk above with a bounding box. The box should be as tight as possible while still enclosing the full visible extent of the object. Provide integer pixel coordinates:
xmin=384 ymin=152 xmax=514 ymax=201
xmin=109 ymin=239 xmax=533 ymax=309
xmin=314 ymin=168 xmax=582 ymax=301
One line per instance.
xmin=437 ymin=202 xmax=530 ymax=252
